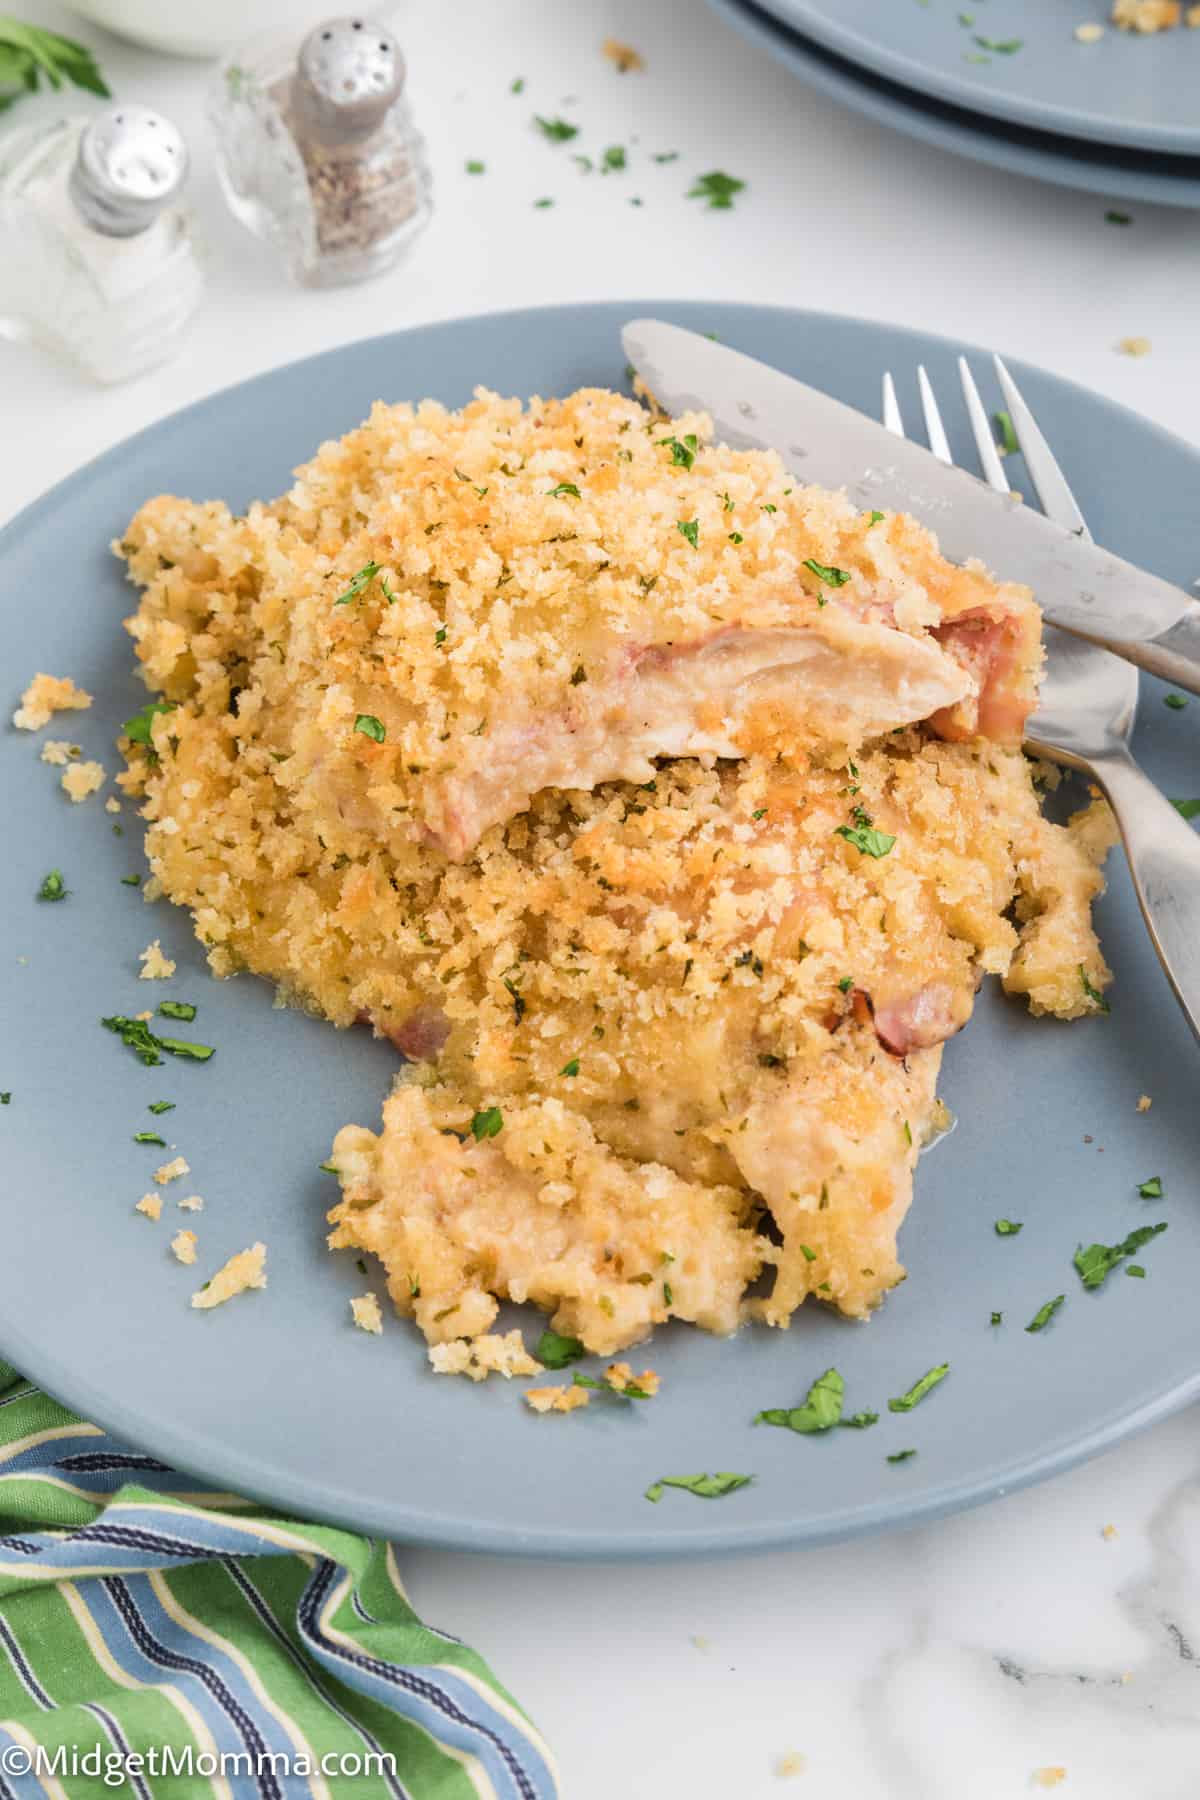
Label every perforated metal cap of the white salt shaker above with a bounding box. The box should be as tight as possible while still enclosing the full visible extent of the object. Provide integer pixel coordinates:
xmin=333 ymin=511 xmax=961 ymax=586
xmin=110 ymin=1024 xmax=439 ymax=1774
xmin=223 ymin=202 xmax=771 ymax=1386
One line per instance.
xmin=70 ymin=106 xmax=187 ymax=238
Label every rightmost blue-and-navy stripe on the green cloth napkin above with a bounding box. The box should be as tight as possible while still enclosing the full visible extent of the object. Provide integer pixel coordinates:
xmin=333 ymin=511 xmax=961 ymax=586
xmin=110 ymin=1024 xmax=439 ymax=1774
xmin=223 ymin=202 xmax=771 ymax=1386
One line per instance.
xmin=297 ymin=1559 xmax=556 ymax=1800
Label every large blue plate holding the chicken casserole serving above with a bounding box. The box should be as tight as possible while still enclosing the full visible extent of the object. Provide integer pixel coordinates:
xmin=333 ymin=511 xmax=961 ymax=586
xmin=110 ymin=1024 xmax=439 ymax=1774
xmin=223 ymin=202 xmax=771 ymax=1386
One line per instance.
xmin=0 ymin=301 xmax=1200 ymax=1557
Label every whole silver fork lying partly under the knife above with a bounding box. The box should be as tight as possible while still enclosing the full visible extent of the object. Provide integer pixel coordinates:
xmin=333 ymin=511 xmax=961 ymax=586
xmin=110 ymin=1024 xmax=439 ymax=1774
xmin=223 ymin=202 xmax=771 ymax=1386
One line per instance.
xmin=883 ymin=356 xmax=1200 ymax=1037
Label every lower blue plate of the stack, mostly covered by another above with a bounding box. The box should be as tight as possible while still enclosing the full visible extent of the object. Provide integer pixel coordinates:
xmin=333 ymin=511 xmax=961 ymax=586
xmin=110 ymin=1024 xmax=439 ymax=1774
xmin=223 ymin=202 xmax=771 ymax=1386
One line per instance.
xmin=709 ymin=0 xmax=1200 ymax=207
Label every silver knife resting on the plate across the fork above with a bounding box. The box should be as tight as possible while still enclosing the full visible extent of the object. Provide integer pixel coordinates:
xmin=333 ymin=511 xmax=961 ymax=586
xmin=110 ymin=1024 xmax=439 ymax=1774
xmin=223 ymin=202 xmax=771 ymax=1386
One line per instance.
xmin=621 ymin=319 xmax=1200 ymax=693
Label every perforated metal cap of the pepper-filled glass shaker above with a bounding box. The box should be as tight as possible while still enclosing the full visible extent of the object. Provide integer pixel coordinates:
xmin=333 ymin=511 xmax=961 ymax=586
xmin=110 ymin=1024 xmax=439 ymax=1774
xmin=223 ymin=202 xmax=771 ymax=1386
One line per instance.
xmin=291 ymin=18 xmax=405 ymax=144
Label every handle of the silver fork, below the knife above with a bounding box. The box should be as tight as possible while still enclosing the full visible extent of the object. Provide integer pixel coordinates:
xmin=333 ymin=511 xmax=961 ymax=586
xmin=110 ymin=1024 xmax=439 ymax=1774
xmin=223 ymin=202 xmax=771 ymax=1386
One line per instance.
xmin=1092 ymin=749 xmax=1200 ymax=1039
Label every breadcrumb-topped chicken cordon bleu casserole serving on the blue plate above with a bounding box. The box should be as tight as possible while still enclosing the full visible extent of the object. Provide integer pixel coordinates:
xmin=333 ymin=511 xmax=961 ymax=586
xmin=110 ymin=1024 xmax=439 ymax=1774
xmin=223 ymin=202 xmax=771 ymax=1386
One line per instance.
xmin=119 ymin=389 xmax=1114 ymax=1366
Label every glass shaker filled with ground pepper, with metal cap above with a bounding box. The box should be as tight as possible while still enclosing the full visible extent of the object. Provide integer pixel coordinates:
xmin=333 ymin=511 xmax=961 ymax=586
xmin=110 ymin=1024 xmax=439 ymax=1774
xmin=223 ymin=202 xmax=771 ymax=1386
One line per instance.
xmin=210 ymin=18 xmax=432 ymax=286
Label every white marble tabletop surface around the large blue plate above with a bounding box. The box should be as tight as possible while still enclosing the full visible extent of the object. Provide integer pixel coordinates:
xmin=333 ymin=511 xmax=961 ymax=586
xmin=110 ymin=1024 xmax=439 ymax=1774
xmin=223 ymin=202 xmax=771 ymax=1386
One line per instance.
xmin=9 ymin=0 xmax=1200 ymax=1800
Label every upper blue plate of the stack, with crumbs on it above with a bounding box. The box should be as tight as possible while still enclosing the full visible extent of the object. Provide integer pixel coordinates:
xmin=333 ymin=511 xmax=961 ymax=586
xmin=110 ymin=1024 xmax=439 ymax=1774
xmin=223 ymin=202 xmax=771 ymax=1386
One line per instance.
xmin=763 ymin=0 xmax=1200 ymax=157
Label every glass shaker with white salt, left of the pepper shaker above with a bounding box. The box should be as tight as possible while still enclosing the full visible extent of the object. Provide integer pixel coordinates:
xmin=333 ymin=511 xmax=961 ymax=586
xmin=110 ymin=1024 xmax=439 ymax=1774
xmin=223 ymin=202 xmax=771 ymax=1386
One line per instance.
xmin=0 ymin=106 xmax=201 ymax=382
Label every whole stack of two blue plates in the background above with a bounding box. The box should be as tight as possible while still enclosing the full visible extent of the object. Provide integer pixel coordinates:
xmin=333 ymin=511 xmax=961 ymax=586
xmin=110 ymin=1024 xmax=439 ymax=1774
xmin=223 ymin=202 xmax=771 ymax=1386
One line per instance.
xmin=709 ymin=0 xmax=1200 ymax=207
